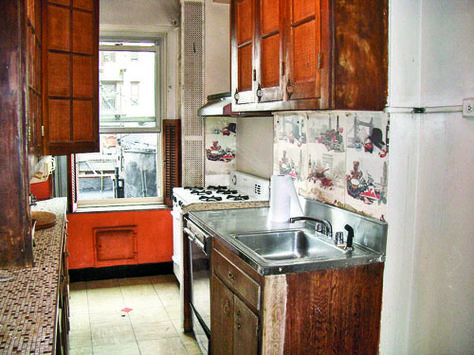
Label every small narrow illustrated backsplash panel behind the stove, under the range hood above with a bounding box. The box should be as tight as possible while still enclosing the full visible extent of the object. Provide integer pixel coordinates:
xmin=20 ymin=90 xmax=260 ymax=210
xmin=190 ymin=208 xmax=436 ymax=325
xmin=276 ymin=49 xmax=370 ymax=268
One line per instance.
xmin=204 ymin=117 xmax=237 ymax=176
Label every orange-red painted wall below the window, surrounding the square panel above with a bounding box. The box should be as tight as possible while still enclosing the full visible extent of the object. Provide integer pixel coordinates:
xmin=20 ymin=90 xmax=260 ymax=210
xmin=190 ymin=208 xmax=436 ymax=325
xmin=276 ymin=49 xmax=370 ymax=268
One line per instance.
xmin=67 ymin=209 xmax=173 ymax=269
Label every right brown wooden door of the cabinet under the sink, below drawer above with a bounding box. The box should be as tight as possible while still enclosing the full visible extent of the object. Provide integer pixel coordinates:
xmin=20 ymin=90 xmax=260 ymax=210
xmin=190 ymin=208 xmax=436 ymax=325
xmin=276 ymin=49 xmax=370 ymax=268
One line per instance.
xmin=233 ymin=296 xmax=258 ymax=354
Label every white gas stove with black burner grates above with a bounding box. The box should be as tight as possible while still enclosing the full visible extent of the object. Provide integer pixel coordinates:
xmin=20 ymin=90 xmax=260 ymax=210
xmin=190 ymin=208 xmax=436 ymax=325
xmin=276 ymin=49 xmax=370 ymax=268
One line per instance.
xmin=171 ymin=171 xmax=270 ymax=283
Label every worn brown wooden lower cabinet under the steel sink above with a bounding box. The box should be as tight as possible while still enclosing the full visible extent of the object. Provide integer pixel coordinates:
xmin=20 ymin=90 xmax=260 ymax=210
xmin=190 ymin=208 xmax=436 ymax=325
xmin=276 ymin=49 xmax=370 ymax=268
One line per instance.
xmin=211 ymin=241 xmax=384 ymax=355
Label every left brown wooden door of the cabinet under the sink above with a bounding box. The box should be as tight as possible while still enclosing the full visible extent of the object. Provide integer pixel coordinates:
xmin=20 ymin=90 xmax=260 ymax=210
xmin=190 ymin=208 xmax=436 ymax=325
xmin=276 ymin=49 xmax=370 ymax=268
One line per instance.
xmin=211 ymin=276 xmax=234 ymax=355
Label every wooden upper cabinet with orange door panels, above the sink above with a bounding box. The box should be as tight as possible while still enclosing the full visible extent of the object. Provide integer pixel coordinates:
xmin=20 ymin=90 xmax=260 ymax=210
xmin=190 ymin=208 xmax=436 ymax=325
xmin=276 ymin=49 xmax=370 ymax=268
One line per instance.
xmin=231 ymin=0 xmax=388 ymax=112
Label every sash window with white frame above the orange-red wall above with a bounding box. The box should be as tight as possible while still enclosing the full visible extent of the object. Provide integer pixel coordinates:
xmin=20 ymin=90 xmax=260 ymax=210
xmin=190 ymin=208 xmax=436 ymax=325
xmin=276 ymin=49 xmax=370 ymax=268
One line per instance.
xmin=76 ymin=38 xmax=163 ymax=206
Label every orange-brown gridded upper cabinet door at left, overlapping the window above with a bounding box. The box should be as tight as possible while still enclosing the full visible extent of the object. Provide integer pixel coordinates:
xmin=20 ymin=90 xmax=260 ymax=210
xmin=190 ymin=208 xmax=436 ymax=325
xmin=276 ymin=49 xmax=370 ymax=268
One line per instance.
xmin=42 ymin=0 xmax=99 ymax=155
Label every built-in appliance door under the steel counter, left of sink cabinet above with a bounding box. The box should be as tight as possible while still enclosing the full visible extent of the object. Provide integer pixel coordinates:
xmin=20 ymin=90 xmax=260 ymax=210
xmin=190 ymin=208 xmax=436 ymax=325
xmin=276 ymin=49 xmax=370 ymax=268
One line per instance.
xmin=187 ymin=233 xmax=211 ymax=354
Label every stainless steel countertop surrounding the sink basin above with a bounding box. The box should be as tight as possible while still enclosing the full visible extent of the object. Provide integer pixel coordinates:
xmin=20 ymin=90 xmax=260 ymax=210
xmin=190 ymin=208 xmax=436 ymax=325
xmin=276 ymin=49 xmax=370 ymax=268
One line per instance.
xmin=188 ymin=207 xmax=384 ymax=275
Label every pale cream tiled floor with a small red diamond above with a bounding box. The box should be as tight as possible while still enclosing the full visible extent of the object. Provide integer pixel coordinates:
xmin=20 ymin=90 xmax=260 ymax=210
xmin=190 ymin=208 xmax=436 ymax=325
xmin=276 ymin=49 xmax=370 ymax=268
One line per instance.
xmin=69 ymin=275 xmax=201 ymax=355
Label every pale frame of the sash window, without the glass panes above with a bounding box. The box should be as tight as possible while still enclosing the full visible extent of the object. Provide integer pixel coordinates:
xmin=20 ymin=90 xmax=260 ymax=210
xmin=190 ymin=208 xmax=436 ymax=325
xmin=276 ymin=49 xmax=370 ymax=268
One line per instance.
xmin=75 ymin=34 xmax=166 ymax=209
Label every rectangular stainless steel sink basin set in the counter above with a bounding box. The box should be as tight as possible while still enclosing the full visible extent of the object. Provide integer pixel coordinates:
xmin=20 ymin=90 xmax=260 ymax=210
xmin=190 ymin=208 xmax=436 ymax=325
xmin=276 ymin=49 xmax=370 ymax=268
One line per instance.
xmin=234 ymin=230 xmax=344 ymax=261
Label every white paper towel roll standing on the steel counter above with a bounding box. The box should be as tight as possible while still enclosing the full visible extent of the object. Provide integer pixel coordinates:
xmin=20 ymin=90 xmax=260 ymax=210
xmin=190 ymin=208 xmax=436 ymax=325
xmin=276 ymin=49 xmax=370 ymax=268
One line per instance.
xmin=270 ymin=175 xmax=303 ymax=222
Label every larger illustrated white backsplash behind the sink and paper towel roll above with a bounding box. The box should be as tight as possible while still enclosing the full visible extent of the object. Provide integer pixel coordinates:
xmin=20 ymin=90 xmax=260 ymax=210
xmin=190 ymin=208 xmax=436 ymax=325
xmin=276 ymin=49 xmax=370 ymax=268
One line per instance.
xmin=273 ymin=111 xmax=389 ymax=220
